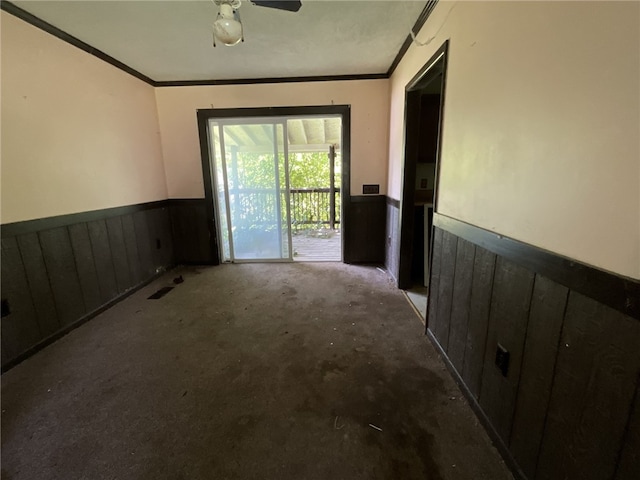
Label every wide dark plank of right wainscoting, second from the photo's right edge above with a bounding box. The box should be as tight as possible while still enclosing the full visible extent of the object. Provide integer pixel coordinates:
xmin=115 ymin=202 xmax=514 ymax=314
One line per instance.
xmin=536 ymin=292 xmax=640 ymax=480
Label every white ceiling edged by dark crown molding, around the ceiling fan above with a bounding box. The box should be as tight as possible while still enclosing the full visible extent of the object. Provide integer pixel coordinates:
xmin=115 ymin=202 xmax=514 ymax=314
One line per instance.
xmin=13 ymin=0 xmax=426 ymax=81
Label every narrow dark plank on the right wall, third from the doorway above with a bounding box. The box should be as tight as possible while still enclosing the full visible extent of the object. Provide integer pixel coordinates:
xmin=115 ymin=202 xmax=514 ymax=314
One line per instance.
xmin=447 ymin=238 xmax=475 ymax=373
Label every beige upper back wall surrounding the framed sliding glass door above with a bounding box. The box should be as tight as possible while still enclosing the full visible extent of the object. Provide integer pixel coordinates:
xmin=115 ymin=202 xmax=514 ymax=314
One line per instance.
xmin=156 ymin=80 xmax=389 ymax=198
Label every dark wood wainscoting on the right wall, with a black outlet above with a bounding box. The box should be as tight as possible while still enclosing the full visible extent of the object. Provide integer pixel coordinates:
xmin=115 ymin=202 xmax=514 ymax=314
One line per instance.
xmin=427 ymin=215 xmax=640 ymax=480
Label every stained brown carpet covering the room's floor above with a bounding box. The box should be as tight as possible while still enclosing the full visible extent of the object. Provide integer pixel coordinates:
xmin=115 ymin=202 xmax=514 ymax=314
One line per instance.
xmin=1 ymin=263 xmax=512 ymax=480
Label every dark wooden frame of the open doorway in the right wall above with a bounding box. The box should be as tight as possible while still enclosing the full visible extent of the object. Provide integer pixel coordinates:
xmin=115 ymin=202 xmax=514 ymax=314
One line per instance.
xmin=398 ymin=40 xmax=449 ymax=290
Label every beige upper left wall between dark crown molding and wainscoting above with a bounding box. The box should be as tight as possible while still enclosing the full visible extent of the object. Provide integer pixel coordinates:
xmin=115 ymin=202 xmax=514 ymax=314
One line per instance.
xmin=1 ymin=12 xmax=167 ymax=223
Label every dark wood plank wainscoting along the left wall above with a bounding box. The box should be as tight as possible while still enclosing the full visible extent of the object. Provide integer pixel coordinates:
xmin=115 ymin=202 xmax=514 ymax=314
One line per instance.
xmin=1 ymin=201 xmax=174 ymax=371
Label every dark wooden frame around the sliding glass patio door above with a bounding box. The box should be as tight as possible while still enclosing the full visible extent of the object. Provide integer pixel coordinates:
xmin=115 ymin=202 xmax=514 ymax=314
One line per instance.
xmin=196 ymin=105 xmax=351 ymax=265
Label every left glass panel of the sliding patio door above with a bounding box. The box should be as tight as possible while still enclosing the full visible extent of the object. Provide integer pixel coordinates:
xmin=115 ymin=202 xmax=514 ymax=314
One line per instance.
xmin=209 ymin=118 xmax=292 ymax=262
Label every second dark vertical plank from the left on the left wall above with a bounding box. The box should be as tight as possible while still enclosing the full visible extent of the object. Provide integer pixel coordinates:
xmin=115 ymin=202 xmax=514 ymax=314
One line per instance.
xmin=16 ymin=233 xmax=60 ymax=337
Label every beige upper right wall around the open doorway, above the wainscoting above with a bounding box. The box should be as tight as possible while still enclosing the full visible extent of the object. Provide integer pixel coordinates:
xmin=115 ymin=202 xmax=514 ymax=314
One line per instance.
xmin=388 ymin=2 xmax=640 ymax=278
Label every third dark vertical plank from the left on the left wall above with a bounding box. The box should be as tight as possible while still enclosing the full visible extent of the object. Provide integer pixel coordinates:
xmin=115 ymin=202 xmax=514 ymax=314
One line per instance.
xmin=39 ymin=227 xmax=86 ymax=326
